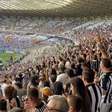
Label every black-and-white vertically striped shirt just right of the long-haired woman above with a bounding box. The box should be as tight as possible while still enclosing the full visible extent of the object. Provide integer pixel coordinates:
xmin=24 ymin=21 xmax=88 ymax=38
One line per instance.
xmin=87 ymin=84 xmax=102 ymax=112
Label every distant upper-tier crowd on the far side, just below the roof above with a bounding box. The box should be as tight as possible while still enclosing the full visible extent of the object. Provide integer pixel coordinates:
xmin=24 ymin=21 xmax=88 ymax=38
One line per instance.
xmin=0 ymin=16 xmax=85 ymax=35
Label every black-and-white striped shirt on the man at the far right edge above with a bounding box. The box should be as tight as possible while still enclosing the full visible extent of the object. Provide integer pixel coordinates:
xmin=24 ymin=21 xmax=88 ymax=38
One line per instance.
xmin=100 ymin=73 xmax=112 ymax=103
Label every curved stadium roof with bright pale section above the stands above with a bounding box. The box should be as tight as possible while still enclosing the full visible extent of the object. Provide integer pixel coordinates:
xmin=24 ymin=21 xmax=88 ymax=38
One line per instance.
xmin=0 ymin=0 xmax=112 ymax=16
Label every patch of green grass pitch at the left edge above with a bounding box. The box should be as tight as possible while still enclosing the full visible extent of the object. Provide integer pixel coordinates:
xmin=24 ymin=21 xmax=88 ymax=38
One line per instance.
xmin=0 ymin=52 xmax=22 ymax=64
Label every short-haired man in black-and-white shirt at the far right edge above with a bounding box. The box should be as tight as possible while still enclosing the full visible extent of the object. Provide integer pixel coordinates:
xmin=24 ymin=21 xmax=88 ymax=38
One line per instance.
xmin=100 ymin=59 xmax=112 ymax=112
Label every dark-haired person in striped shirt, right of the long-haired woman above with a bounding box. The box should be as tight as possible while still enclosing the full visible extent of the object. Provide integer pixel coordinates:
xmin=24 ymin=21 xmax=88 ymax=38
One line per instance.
xmin=82 ymin=70 xmax=102 ymax=112
